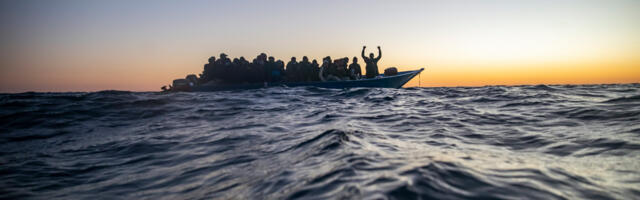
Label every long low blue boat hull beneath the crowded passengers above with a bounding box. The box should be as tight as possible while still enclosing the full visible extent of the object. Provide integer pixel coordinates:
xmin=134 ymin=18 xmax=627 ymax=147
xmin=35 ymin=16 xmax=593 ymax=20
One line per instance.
xmin=172 ymin=68 xmax=424 ymax=92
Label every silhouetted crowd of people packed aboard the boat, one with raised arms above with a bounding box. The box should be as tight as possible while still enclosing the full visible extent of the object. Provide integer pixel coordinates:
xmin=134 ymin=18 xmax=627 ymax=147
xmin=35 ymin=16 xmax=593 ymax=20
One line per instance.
xmin=197 ymin=46 xmax=382 ymax=84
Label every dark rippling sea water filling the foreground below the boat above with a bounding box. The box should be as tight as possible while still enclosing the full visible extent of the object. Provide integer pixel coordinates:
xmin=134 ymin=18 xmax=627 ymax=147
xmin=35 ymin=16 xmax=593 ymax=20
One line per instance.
xmin=0 ymin=84 xmax=640 ymax=199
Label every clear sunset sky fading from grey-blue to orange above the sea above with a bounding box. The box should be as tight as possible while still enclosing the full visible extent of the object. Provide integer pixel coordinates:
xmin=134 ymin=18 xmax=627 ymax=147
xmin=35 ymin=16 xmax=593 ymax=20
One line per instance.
xmin=0 ymin=0 xmax=640 ymax=92
